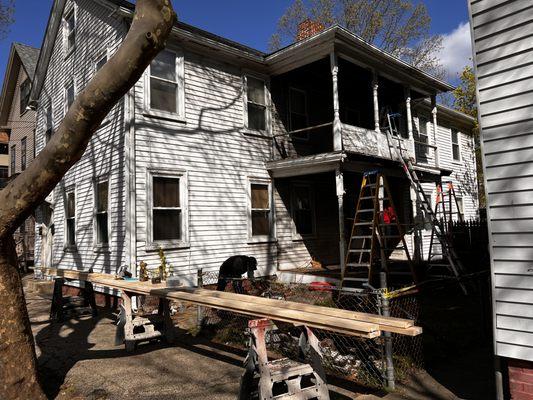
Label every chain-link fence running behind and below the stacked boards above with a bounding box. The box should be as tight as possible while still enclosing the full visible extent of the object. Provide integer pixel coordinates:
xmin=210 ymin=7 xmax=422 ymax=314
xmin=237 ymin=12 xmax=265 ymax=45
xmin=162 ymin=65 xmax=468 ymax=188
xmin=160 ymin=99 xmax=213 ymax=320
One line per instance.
xmin=191 ymin=272 xmax=423 ymax=388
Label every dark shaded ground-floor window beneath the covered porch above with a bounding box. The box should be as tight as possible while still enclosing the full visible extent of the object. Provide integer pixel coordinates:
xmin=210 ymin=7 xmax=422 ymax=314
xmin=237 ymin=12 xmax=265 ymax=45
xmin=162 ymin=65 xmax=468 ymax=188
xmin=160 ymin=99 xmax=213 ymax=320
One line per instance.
xmin=292 ymin=185 xmax=315 ymax=237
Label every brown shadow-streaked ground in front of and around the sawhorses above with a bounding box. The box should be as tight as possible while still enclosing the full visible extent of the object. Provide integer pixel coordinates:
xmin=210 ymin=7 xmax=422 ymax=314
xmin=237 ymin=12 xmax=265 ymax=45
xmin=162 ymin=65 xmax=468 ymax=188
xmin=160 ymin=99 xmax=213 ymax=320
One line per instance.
xmin=25 ymin=277 xmax=491 ymax=400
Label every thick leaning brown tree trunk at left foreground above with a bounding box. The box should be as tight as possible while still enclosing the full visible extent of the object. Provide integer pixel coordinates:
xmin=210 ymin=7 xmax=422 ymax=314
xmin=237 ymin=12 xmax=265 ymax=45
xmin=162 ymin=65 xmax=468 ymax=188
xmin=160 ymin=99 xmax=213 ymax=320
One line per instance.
xmin=0 ymin=0 xmax=176 ymax=400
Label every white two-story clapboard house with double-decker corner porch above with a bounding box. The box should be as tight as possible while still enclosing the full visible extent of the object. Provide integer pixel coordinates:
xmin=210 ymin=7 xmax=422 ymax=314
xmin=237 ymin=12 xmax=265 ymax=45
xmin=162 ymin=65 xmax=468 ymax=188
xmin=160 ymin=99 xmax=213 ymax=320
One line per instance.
xmin=32 ymin=0 xmax=478 ymax=288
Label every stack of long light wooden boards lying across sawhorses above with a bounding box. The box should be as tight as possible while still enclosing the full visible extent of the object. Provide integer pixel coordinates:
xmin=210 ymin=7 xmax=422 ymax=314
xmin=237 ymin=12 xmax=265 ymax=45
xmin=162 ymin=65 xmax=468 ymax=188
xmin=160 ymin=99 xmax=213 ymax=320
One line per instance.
xmin=43 ymin=269 xmax=422 ymax=338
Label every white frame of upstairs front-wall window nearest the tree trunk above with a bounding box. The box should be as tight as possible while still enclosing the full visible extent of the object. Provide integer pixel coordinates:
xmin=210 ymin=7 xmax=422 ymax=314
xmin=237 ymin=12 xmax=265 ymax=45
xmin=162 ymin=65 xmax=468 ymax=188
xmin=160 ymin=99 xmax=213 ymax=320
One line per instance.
xmin=144 ymin=48 xmax=185 ymax=122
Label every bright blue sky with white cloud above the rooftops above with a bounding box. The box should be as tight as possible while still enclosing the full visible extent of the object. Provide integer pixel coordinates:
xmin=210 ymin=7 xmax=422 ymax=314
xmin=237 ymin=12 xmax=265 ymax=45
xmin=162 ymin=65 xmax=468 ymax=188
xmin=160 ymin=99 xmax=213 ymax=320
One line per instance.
xmin=0 ymin=0 xmax=470 ymax=81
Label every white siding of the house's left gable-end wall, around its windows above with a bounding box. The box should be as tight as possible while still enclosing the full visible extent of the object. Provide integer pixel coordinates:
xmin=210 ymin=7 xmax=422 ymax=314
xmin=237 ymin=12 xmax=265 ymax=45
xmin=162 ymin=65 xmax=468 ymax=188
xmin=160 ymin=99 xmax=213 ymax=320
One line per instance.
xmin=35 ymin=0 xmax=125 ymax=272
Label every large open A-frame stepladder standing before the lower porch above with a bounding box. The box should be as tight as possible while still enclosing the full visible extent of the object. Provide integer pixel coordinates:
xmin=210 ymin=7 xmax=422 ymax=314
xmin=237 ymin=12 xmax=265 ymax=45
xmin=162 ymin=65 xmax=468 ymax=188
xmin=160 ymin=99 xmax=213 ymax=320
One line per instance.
xmin=341 ymin=170 xmax=417 ymax=288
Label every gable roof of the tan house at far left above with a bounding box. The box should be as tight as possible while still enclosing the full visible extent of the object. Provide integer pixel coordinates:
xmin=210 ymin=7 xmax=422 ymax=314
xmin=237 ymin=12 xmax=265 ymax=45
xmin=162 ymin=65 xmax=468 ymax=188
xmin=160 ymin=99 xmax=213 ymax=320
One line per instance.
xmin=0 ymin=43 xmax=39 ymax=126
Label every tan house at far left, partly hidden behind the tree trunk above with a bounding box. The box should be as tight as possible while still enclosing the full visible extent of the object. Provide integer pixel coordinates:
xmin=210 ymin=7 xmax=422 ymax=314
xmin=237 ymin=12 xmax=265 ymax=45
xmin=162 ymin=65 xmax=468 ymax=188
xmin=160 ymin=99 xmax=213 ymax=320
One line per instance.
xmin=0 ymin=43 xmax=39 ymax=265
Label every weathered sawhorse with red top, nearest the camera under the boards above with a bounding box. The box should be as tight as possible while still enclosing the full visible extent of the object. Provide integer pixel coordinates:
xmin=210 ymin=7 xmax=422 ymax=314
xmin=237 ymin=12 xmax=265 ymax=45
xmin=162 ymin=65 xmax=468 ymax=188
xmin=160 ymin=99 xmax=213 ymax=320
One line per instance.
xmin=239 ymin=319 xmax=329 ymax=400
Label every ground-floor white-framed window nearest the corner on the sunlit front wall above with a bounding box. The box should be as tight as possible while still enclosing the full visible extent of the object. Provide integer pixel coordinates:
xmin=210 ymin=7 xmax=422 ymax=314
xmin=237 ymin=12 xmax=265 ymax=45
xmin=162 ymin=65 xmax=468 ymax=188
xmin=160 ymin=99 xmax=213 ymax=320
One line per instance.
xmin=148 ymin=171 xmax=188 ymax=245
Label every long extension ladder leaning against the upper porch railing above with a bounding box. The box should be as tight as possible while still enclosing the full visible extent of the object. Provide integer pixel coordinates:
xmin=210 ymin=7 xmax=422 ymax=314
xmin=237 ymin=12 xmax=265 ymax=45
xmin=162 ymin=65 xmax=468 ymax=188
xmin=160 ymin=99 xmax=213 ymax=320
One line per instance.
xmin=384 ymin=114 xmax=467 ymax=294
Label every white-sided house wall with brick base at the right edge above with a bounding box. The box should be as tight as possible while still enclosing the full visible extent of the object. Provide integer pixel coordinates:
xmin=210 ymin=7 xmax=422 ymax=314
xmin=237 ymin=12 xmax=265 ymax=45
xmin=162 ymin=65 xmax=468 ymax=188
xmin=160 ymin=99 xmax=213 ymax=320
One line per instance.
xmin=469 ymin=0 xmax=533 ymax=400
